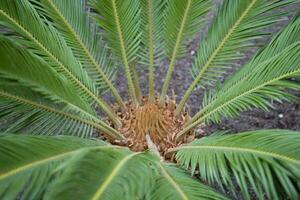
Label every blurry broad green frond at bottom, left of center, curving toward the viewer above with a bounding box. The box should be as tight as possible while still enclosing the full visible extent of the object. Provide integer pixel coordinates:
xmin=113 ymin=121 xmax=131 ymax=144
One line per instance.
xmin=45 ymin=149 xmax=155 ymax=200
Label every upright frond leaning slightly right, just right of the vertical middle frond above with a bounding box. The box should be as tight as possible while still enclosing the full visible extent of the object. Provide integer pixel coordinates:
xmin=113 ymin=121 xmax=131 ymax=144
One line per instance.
xmin=161 ymin=0 xmax=211 ymax=102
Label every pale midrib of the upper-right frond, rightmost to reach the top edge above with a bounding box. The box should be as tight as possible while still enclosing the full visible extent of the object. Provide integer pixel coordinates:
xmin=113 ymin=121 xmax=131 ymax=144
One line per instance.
xmin=175 ymin=0 xmax=257 ymax=115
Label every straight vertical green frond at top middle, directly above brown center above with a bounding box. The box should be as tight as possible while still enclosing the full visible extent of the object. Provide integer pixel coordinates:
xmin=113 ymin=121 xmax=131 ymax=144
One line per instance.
xmin=139 ymin=0 xmax=166 ymax=100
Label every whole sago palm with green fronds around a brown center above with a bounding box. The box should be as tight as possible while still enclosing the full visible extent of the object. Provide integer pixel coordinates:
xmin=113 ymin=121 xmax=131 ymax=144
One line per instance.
xmin=0 ymin=0 xmax=300 ymax=200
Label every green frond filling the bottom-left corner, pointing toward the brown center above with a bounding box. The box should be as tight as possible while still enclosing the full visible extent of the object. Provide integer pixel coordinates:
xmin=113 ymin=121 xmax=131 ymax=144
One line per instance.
xmin=0 ymin=135 xmax=108 ymax=199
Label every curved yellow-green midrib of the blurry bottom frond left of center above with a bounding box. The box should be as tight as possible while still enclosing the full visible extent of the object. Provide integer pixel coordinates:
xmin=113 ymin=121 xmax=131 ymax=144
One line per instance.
xmin=92 ymin=152 xmax=141 ymax=200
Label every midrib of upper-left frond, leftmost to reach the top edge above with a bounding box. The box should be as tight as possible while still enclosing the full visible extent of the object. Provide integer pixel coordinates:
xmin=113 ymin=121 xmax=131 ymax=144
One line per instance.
xmin=47 ymin=0 xmax=124 ymax=108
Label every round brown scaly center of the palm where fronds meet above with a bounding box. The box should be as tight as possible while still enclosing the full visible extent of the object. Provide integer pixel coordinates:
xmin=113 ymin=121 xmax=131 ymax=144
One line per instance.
xmin=105 ymin=98 xmax=194 ymax=157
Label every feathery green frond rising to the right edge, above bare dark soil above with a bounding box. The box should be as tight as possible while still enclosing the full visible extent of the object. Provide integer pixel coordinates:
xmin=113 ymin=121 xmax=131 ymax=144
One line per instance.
xmin=178 ymin=16 xmax=300 ymax=137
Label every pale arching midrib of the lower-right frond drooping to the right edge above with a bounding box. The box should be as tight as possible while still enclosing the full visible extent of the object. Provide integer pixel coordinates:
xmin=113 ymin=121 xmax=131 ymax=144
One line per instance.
xmin=172 ymin=145 xmax=300 ymax=165
